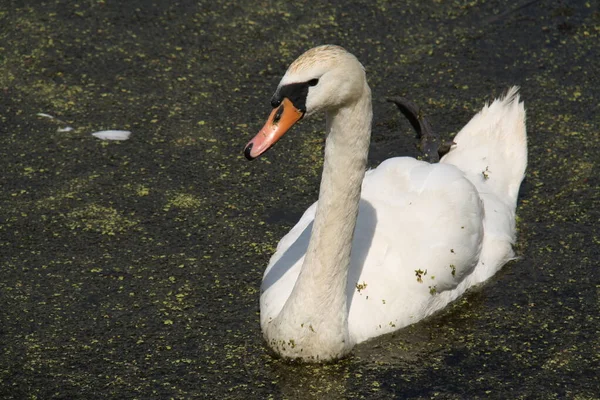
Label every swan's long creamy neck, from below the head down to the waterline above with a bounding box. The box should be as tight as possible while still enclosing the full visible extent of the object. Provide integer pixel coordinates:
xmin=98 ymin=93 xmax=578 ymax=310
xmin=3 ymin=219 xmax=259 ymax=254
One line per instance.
xmin=266 ymin=82 xmax=372 ymax=360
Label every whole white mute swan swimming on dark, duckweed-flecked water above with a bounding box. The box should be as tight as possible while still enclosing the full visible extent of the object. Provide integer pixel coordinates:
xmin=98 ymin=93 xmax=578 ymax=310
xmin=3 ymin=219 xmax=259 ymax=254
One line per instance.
xmin=244 ymin=45 xmax=527 ymax=362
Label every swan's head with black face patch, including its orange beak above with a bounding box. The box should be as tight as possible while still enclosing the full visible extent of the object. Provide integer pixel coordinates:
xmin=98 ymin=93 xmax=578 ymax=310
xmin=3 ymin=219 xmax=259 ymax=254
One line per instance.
xmin=244 ymin=45 xmax=366 ymax=160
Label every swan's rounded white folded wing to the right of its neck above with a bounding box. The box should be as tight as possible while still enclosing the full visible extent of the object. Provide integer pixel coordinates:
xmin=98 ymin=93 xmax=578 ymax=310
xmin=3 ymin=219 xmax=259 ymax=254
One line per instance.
xmin=348 ymin=158 xmax=484 ymax=342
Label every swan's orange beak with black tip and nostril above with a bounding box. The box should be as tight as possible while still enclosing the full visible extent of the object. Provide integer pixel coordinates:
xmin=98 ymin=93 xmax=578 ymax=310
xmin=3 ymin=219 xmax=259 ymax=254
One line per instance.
xmin=244 ymin=98 xmax=304 ymax=160
